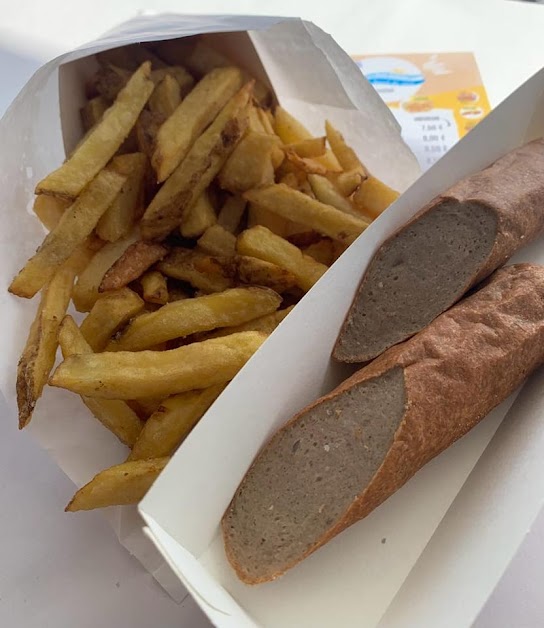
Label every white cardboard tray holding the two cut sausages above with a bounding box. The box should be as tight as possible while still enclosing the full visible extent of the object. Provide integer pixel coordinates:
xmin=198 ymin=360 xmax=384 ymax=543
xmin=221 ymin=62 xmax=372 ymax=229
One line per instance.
xmin=140 ymin=70 xmax=544 ymax=628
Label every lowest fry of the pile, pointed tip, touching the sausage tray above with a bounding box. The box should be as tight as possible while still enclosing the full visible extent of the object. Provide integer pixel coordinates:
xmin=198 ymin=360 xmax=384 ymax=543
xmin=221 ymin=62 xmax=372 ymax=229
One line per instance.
xmin=66 ymin=458 xmax=169 ymax=512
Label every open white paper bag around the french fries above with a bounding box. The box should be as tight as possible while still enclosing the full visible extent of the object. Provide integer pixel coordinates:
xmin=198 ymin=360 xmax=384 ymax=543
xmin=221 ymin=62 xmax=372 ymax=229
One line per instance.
xmin=0 ymin=15 xmax=419 ymax=600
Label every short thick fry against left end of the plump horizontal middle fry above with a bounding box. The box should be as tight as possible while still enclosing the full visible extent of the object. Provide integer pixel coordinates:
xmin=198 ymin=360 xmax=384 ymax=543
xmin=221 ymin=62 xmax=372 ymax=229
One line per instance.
xmin=81 ymin=288 xmax=144 ymax=351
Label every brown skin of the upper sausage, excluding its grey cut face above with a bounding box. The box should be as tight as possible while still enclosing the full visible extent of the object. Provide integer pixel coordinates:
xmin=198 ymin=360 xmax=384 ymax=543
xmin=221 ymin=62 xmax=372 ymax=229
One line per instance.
xmin=333 ymin=139 xmax=544 ymax=362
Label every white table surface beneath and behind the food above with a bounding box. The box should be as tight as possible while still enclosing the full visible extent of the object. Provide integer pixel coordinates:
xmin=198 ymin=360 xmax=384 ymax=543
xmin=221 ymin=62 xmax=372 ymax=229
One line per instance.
xmin=0 ymin=0 xmax=544 ymax=628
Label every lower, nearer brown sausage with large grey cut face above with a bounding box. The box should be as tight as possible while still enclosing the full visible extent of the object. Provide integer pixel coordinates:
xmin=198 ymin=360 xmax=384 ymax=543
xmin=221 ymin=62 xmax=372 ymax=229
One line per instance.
xmin=222 ymin=264 xmax=544 ymax=584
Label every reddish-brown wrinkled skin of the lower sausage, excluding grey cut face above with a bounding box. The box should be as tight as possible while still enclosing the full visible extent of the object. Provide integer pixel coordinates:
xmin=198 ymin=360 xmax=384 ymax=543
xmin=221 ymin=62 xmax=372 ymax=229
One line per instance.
xmin=222 ymin=264 xmax=544 ymax=584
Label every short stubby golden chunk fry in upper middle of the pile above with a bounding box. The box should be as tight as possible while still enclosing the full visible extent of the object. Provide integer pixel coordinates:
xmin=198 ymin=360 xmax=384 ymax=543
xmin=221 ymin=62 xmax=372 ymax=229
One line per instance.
xmin=218 ymin=131 xmax=279 ymax=194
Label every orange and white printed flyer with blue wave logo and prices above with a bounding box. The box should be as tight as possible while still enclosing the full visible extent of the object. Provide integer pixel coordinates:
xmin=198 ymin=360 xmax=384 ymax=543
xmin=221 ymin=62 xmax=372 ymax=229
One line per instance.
xmin=353 ymin=52 xmax=490 ymax=170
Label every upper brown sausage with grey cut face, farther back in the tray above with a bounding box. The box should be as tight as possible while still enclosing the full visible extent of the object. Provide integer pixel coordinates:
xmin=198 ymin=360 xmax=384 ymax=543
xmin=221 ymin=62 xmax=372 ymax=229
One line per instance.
xmin=333 ymin=139 xmax=544 ymax=362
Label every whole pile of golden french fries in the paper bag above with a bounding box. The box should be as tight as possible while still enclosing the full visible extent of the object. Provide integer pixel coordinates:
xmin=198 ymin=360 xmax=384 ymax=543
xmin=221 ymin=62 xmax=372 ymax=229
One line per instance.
xmin=9 ymin=38 xmax=398 ymax=511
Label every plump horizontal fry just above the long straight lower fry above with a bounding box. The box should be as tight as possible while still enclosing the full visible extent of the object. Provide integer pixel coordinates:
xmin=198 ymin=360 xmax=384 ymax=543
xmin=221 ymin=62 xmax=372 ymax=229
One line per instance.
xmin=110 ymin=286 xmax=281 ymax=351
